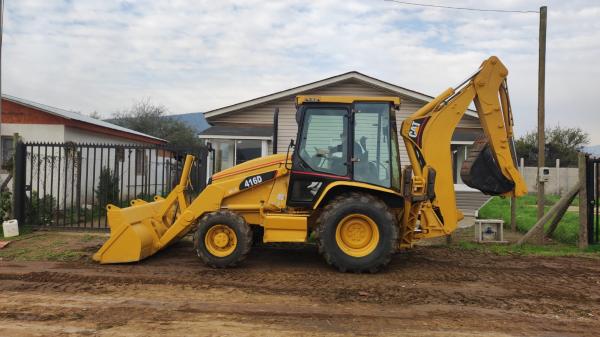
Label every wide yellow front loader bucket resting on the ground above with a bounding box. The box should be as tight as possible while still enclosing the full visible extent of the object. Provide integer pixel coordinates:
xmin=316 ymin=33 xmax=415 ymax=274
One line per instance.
xmin=93 ymin=155 xmax=194 ymax=263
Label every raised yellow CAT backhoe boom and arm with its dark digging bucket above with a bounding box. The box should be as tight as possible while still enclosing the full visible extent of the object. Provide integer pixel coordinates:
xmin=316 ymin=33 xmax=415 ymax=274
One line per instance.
xmin=400 ymin=56 xmax=527 ymax=238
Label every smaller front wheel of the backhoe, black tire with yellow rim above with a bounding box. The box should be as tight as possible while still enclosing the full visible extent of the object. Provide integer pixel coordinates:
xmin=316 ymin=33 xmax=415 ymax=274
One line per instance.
xmin=194 ymin=211 xmax=252 ymax=268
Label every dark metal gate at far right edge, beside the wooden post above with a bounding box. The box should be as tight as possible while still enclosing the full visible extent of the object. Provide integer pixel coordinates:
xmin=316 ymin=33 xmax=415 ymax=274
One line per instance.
xmin=585 ymin=157 xmax=600 ymax=244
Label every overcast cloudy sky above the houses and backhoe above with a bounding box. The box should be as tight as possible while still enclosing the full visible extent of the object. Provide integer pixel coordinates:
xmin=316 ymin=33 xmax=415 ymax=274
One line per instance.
xmin=2 ymin=0 xmax=600 ymax=144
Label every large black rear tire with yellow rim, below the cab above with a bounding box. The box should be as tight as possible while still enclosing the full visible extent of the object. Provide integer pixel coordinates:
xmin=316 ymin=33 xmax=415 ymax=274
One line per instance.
xmin=316 ymin=192 xmax=398 ymax=273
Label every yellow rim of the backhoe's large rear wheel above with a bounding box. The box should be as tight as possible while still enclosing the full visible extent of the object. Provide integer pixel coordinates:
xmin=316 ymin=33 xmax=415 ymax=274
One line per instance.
xmin=335 ymin=214 xmax=379 ymax=257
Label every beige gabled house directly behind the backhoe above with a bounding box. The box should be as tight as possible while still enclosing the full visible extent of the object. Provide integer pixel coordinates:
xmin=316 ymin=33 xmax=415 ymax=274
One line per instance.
xmin=199 ymin=71 xmax=487 ymax=213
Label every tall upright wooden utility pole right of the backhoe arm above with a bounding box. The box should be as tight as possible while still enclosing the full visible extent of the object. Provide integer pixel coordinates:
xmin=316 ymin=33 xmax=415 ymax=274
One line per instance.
xmin=534 ymin=6 xmax=547 ymax=244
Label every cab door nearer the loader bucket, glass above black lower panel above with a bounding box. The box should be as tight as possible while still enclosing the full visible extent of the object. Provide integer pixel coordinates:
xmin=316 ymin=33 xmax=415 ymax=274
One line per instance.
xmin=287 ymin=103 xmax=352 ymax=207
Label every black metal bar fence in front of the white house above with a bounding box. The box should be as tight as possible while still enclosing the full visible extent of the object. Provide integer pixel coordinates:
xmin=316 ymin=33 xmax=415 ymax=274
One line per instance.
xmin=14 ymin=143 xmax=208 ymax=230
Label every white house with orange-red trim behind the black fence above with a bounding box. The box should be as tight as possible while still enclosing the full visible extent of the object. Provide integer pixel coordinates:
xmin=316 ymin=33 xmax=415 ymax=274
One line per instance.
xmin=0 ymin=95 xmax=171 ymax=207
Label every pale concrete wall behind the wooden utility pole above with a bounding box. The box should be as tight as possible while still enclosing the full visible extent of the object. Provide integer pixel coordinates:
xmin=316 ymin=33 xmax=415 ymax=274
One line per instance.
xmin=519 ymin=166 xmax=579 ymax=195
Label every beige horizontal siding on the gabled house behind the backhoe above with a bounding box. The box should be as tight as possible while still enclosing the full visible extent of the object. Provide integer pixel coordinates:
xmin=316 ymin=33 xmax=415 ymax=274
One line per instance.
xmin=207 ymin=79 xmax=479 ymax=165
